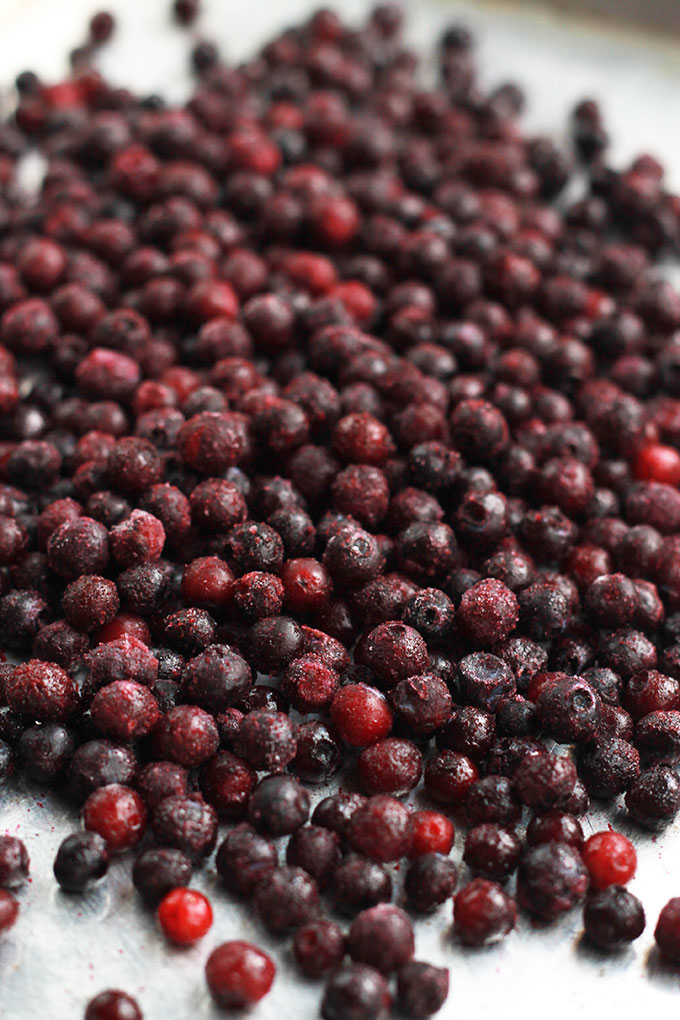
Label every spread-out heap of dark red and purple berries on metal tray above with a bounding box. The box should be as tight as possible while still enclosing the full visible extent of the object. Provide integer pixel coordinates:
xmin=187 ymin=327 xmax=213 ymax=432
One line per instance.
xmin=0 ymin=0 xmax=680 ymax=1020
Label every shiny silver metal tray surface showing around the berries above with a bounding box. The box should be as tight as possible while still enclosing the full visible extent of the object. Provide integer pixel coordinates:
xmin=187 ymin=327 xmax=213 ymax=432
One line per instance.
xmin=0 ymin=0 xmax=680 ymax=1020
